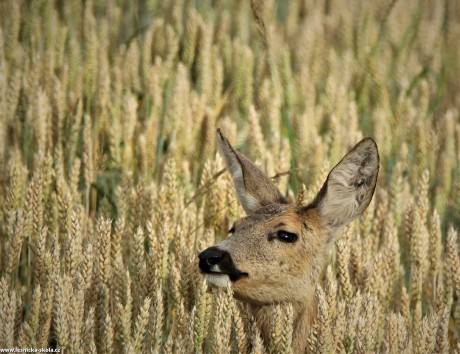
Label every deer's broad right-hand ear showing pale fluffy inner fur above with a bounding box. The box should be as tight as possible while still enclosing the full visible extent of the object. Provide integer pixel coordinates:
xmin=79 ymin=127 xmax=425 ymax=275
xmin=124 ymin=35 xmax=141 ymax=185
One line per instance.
xmin=307 ymin=138 xmax=379 ymax=227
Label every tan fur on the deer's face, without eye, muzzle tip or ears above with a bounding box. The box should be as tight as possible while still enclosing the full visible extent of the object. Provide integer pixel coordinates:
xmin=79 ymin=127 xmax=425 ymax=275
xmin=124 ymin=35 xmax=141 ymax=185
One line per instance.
xmin=216 ymin=204 xmax=322 ymax=304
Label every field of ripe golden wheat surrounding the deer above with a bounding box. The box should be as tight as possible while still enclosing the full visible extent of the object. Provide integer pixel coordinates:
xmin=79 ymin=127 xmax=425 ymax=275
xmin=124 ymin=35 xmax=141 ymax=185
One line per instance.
xmin=0 ymin=0 xmax=460 ymax=353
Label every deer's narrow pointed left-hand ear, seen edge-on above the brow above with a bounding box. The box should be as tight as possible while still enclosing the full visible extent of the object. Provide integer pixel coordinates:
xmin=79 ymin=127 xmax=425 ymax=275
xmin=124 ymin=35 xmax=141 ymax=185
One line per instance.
xmin=217 ymin=129 xmax=287 ymax=214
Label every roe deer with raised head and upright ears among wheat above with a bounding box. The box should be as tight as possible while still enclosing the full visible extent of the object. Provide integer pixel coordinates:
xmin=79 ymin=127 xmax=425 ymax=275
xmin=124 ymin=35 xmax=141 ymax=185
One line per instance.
xmin=198 ymin=129 xmax=379 ymax=353
